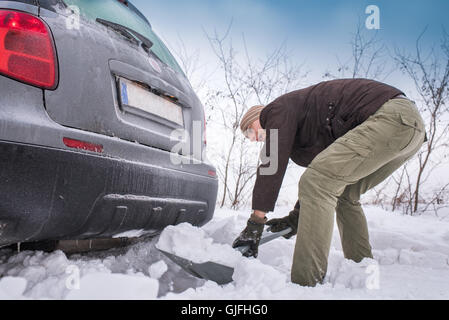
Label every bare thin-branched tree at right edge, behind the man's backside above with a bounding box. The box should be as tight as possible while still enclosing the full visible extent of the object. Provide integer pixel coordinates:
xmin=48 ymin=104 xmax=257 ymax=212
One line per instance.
xmin=395 ymin=30 xmax=449 ymax=213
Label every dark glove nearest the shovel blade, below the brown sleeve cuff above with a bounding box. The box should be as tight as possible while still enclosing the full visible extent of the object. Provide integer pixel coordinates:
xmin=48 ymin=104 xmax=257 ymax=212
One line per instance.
xmin=232 ymin=213 xmax=267 ymax=258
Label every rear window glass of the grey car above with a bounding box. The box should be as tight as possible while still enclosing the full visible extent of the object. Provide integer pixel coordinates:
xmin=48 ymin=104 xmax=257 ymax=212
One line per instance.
xmin=64 ymin=0 xmax=184 ymax=74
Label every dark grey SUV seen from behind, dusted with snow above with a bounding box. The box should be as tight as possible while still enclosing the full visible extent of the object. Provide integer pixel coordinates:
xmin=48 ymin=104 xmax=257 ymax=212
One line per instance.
xmin=0 ymin=0 xmax=218 ymax=246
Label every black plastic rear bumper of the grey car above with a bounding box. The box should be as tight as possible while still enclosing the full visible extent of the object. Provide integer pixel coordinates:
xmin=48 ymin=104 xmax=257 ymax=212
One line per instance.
xmin=0 ymin=141 xmax=218 ymax=246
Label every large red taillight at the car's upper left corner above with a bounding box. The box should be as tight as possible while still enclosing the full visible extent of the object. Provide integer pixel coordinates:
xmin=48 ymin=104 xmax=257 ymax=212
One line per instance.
xmin=0 ymin=10 xmax=58 ymax=89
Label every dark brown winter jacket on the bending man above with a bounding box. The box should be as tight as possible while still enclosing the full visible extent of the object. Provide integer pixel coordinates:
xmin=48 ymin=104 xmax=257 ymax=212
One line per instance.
xmin=252 ymin=79 xmax=403 ymax=212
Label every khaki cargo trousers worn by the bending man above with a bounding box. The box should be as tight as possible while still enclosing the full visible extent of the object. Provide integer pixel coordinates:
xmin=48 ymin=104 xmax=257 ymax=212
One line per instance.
xmin=291 ymin=98 xmax=425 ymax=286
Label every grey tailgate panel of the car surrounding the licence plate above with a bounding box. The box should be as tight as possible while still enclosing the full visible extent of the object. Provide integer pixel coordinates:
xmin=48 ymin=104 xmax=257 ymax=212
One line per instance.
xmin=40 ymin=2 xmax=204 ymax=158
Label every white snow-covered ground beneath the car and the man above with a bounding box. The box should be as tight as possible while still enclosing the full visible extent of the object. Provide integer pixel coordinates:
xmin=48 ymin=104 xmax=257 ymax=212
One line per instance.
xmin=0 ymin=207 xmax=449 ymax=300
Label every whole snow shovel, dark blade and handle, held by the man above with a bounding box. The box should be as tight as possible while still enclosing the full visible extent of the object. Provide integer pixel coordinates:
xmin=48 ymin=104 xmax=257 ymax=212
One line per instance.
xmin=159 ymin=228 xmax=292 ymax=285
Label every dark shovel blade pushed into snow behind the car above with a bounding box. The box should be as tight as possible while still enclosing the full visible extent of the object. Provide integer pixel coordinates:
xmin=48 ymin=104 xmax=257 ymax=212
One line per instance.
xmin=159 ymin=250 xmax=234 ymax=285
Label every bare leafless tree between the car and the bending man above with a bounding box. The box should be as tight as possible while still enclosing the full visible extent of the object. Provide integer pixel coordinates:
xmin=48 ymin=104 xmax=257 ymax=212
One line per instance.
xmin=205 ymin=24 xmax=305 ymax=209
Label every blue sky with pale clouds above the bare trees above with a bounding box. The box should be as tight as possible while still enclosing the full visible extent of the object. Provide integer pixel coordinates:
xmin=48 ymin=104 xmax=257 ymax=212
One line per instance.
xmin=132 ymin=0 xmax=449 ymax=89
